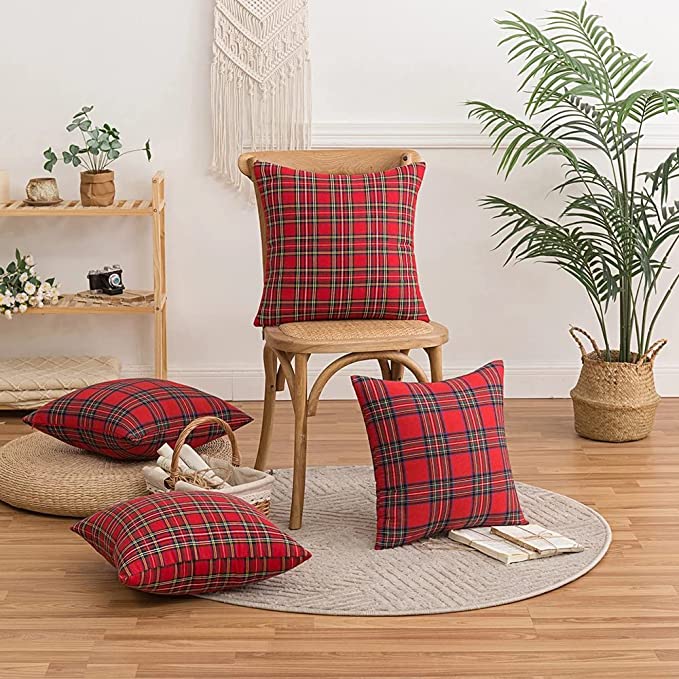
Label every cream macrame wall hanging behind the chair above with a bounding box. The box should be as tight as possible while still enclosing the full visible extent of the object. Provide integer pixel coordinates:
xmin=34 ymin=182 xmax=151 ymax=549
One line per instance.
xmin=212 ymin=0 xmax=311 ymax=189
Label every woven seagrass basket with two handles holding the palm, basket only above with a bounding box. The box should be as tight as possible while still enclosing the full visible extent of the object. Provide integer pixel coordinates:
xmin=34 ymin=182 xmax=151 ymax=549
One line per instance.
xmin=570 ymin=327 xmax=667 ymax=443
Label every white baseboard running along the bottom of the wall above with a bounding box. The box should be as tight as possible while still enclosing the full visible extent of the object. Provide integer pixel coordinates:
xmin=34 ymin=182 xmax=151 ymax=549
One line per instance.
xmin=123 ymin=363 xmax=679 ymax=401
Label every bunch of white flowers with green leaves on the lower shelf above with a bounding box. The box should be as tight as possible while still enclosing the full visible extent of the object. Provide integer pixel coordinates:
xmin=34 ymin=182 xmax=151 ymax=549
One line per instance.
xmin=0 ymin=250 xmax=59 ymax=319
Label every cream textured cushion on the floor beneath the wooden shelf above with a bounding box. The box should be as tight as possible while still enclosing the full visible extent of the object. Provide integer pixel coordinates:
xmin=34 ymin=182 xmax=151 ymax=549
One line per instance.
xmin=0 ymin=356 xmax=120 ymax=410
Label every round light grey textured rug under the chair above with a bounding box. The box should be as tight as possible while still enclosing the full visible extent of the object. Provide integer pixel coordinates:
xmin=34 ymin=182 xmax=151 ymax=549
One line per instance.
xmin=205 ymin=467 xmax=611 ymax=615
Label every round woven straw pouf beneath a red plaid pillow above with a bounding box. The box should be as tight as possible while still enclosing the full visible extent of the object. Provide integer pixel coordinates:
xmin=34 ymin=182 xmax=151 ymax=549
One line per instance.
xmin=0 ymin=431 xmax=231 ymax=517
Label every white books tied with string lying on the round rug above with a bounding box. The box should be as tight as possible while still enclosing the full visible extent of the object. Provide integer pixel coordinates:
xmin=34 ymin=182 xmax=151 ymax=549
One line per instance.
xmin=448 ymin=523 xmax=584 ymax=564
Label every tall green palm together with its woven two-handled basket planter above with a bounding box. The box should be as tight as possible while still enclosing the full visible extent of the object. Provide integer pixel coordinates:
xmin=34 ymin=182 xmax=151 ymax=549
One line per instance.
xmin=467 ymin=4 xmax=679 ymax=441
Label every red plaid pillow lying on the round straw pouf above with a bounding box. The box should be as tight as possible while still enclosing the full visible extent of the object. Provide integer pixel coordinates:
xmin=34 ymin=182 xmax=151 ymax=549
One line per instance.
xmin=24 ymin=379 xmax=252 ymax=460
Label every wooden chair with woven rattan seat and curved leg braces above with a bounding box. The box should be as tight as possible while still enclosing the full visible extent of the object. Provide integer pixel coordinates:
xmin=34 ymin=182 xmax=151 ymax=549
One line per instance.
xmin=238 ymin=149 xmax=448 ymax=529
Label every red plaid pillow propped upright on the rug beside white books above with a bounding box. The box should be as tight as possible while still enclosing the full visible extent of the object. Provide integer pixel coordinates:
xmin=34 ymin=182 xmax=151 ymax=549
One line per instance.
xmin=351 ymin=361 xmax=527 ymax=549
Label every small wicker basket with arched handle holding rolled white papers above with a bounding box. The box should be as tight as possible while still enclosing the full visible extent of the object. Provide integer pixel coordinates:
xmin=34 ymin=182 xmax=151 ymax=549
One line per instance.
xmin=144 ymin=416 xmax=274 ymax=516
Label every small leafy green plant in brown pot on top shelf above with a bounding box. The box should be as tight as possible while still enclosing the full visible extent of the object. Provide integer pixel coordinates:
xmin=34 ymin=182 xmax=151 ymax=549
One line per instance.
xmin=43 ymin=106 xmax=151 ymax=207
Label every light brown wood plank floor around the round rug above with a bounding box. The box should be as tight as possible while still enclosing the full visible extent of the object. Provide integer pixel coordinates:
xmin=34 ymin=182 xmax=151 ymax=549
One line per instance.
xmin=0 ymin=400 xmax=679 ymax=679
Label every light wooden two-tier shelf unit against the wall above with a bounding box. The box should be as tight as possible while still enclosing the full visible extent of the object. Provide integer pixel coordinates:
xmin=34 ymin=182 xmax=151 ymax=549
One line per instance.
xmin=0 ymin=172 xmax=167 ymax=379
